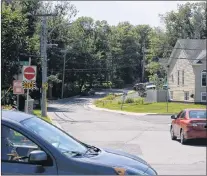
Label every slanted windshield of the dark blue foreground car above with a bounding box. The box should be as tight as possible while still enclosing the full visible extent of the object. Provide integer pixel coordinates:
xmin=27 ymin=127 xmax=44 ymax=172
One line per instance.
xmin=21 ymin=117 xmax=87 ymax=154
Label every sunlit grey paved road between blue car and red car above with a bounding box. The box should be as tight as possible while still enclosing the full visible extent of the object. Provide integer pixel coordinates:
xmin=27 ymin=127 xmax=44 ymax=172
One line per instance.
xmin=49 ymin=91 xmax=206 ymax=175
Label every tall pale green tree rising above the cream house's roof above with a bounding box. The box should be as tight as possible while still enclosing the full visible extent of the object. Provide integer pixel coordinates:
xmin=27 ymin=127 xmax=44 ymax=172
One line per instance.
xmin=160 ymin=2 xmax=207 ymax=47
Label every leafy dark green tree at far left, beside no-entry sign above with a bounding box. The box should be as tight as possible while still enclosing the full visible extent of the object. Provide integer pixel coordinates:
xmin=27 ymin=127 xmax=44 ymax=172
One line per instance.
xmin=1 ymin=3 xmax=28 ymax=86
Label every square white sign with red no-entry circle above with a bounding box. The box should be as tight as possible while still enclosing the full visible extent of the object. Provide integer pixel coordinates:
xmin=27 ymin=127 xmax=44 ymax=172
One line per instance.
xmin=23 ymin=66 xmax=36 ymax=81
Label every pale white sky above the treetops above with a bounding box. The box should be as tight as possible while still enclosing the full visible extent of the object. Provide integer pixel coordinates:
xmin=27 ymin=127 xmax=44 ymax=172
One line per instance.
xmin=71 ymin=1 xmax=200 ymax=27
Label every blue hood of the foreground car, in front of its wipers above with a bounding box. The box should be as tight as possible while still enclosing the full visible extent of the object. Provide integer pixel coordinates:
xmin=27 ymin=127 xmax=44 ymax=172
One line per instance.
xmin=76 ymin=149 xmax=150 ymax=173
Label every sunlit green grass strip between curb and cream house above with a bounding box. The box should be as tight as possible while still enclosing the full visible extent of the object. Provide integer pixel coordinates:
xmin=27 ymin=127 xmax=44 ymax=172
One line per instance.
xmin=95 ymin=100 xmax=206 ymax=114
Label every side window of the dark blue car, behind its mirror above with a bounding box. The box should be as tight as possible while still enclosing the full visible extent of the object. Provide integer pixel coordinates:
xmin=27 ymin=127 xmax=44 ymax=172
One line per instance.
xmin=1 ymin=125 xmax=52 ymax=165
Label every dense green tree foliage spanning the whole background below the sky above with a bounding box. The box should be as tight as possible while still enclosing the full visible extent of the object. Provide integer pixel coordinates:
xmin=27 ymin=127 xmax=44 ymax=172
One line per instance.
xmin=1 ymin=0 xmax=207 ymax=97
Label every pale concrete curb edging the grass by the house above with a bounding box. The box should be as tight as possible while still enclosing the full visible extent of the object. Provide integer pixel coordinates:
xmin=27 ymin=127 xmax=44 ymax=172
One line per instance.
xmin=84 ymin=104 xmax=172 ymax=116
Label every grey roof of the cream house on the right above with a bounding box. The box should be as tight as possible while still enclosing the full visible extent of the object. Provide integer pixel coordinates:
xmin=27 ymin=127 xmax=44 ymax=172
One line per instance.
xmin=168 ymin=39 xmax=206 ymax=65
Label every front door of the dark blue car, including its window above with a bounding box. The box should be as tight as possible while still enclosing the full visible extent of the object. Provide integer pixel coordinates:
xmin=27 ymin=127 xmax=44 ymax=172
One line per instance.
xmin=1 ymin=125 xmax=57 ymax=175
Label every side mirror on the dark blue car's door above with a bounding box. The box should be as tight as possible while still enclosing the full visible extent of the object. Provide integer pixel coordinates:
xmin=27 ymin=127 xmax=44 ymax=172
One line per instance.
xmin=29 ymin=150 xmax=47 ymax=163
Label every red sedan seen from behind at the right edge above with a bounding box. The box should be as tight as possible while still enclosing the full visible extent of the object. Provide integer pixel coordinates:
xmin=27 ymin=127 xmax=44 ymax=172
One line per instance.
xmin=170 ymin=109 xmax=207 ymax=144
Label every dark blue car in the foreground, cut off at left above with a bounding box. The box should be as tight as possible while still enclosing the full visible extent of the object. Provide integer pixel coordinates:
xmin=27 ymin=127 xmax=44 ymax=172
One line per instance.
xmin=1 ymin=111 xmax=157 ymax=175
